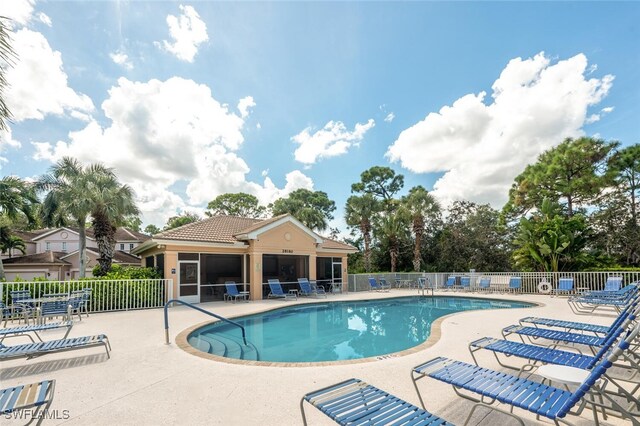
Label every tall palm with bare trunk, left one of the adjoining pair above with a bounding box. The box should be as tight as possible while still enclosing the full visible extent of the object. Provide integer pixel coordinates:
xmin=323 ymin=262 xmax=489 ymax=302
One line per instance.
xmin=36 ymin=157 xmax=113 ymax=278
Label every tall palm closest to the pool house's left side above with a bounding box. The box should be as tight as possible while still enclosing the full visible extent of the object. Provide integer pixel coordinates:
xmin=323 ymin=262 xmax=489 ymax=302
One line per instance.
xmin=91 ymin=173 xmax=139 ymax=275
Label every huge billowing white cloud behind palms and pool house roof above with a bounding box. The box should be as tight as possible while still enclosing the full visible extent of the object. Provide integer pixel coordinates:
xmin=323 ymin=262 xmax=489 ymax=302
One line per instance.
xmin=33 ymin=77 xmax=313 ymax=224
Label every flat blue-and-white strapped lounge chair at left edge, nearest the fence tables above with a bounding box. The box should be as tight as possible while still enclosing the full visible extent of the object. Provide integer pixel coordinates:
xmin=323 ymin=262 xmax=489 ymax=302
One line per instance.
xmin=0 ymin=334 xmax=111 ymax=361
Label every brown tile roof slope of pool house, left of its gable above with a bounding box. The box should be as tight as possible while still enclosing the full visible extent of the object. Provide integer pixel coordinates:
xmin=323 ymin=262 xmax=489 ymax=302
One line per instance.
xmin=153 ymin=216 xmax=262 ymax=244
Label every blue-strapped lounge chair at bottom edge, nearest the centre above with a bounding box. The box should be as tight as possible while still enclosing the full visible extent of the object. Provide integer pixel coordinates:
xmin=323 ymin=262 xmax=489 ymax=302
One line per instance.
xmin=300 ymin=379 xmax=451 ymax=426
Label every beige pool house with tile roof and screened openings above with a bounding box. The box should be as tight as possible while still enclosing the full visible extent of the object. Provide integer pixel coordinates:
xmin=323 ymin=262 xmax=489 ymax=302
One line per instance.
xmin=132 ymin=215 xmax=357 ymax=303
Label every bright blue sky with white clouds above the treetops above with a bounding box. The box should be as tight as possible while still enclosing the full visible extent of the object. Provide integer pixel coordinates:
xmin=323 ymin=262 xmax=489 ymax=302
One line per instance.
xmin=0 ymin=0 xmax=640 ymax=234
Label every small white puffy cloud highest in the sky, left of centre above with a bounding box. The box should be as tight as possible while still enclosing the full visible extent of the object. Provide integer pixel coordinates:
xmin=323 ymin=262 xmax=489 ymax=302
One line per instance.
xmin=156 ymin=5 xmax=209 ymax=62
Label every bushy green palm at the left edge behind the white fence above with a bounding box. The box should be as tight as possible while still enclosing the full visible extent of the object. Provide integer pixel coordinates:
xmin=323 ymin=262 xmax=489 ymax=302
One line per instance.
xmin=0 ymin=176 xmax=38 ymax=280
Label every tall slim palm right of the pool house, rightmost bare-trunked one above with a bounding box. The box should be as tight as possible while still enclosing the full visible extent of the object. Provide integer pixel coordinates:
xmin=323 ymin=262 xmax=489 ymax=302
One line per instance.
xmin=402 ymin=185 xmax=440 ymax=272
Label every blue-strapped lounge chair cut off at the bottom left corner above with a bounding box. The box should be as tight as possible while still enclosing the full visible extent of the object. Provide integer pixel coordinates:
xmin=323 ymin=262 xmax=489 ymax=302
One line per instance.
xmin=0 ymin=380 xmax=56 ymax=425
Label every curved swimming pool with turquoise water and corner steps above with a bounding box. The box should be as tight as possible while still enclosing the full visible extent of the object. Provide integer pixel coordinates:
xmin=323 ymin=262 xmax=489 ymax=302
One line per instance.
xmin=187 ymin=296 xmax=534 ymax=362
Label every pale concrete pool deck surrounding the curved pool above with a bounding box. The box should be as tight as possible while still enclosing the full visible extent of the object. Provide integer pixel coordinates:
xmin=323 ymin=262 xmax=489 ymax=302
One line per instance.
xmin=0 ymin=289 xmax=631 ymax=425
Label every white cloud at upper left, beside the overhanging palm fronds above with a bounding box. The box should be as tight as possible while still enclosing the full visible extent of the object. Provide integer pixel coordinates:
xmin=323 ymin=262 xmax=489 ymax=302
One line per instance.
xmin=5 ymin=28 xmax=94 ymax=122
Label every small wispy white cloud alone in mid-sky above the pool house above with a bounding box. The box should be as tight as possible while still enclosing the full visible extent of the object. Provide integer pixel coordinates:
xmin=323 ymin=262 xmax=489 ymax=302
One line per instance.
xmin=291 ymin=119 xmax=375 ymax=164
